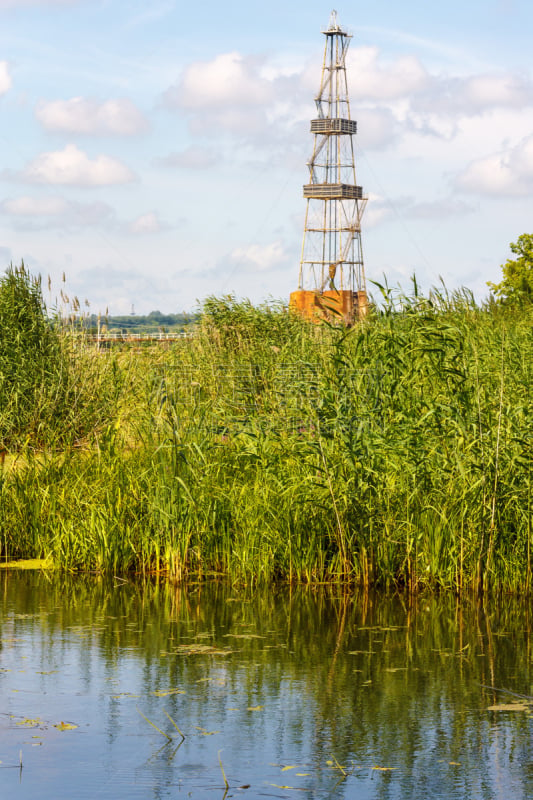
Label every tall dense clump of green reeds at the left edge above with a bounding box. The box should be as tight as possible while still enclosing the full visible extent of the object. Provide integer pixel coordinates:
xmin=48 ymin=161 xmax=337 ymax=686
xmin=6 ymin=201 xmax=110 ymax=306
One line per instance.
xmin=0 ymin=263 xmax=121 ymax=450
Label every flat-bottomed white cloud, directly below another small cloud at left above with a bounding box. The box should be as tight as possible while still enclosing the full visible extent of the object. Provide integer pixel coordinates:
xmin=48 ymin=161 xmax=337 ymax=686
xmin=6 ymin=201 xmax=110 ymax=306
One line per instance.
xmin=14 ymin=144 xmax=135 ymax=186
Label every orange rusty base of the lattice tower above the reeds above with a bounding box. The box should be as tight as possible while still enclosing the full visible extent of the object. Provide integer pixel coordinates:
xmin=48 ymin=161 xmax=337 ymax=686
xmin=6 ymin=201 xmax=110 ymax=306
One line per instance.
xmin=289 ymin=289 xmax=368 ymax=325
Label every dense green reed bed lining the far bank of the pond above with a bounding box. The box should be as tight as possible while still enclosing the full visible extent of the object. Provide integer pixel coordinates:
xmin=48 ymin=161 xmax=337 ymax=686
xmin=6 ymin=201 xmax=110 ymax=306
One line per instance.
xmin=0 ymin=266 xmax=533 ymax=590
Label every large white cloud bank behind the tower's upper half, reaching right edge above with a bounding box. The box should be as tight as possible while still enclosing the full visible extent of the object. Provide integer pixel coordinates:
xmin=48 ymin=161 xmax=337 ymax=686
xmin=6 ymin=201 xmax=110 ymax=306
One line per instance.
xmin=164 ymin=47 xmax=533 ymax=162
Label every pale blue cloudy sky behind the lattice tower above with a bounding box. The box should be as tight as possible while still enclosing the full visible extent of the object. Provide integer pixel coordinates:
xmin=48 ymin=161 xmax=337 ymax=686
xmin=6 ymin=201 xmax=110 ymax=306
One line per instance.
xmin=0 ymin=0 xmax=533 ymax=313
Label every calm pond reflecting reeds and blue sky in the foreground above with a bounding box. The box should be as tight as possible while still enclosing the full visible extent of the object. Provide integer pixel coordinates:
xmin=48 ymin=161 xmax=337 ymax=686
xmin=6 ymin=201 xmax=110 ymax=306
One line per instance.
xmin=0 ymin=571 xmax=533 ymax=800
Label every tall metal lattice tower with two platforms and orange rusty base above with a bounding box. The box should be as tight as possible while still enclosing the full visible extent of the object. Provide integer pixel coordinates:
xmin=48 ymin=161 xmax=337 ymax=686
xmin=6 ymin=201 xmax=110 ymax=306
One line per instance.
xmin=290 ymin=11 xmax=367 ymax=323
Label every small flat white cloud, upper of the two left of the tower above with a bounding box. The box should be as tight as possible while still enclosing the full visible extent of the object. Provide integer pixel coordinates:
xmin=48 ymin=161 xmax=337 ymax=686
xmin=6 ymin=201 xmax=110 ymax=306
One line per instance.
xmin=35 ymin=97 xmax=148 ymax=136
